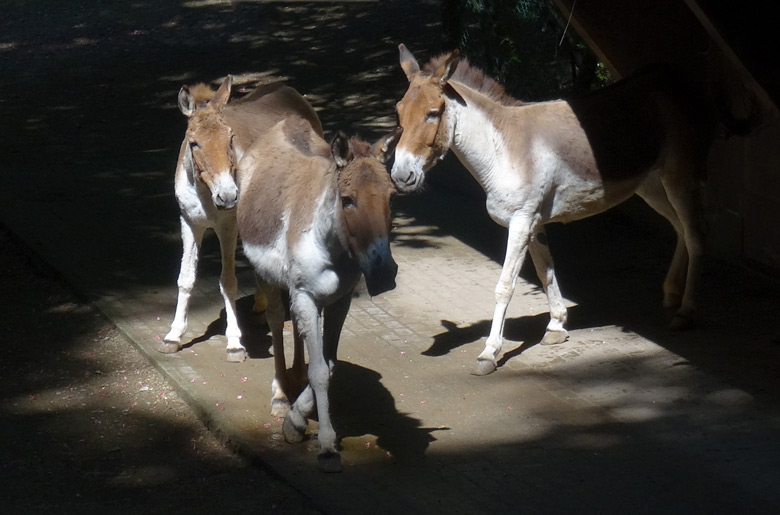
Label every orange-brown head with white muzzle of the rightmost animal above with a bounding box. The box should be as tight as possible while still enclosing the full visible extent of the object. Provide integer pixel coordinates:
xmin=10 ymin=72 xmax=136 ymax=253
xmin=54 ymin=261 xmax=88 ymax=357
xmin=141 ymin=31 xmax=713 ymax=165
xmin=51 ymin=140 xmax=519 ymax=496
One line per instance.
xmin=391 ymin=44 xmax=460 ymax=192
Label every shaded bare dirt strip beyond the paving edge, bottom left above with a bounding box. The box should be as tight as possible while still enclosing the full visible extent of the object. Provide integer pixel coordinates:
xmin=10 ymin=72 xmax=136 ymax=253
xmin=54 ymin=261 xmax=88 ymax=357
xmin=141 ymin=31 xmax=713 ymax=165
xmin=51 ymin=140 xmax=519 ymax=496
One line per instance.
xmin=0 ymin=226 xmax=318 ymax=514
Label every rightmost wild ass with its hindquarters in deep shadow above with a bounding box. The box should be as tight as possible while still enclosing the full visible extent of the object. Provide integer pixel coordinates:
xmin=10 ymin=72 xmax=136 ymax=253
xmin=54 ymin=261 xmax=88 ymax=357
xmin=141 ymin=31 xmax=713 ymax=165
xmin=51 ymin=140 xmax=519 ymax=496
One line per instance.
xmin=392 ymin=45 xmax=714 ymax=375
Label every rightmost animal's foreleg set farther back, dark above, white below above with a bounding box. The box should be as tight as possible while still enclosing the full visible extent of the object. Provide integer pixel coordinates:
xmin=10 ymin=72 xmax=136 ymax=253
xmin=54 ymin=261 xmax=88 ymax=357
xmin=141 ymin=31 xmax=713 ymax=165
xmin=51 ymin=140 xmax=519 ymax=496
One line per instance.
xmin=528 ymin=227 xmax=569 ymax=345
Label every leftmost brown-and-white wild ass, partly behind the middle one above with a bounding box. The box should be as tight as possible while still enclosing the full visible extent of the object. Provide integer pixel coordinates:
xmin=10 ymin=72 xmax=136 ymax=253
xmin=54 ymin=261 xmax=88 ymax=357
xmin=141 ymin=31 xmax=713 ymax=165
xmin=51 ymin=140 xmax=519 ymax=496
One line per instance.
xmin=165 ymin=76 xmax=322 ymax=362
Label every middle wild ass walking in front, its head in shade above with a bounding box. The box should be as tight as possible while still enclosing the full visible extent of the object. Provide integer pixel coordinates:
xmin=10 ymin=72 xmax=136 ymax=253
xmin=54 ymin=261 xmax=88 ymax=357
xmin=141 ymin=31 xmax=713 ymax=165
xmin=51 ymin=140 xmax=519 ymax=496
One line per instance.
xmin=238 ymin=108 xmax=400 ymax=472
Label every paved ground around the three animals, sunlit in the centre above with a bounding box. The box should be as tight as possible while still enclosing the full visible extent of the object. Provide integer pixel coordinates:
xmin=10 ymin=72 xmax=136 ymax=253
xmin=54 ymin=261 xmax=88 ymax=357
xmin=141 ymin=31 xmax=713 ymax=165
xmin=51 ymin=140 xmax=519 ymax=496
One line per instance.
xmin=0 ymin=1 xmax=780 ymax=514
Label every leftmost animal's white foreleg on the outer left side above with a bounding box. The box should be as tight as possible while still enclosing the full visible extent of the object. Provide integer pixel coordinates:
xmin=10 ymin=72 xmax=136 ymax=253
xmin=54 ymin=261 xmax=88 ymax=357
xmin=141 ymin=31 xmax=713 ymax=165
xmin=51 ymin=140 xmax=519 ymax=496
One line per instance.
xmin=158 ymin=217 xmax=206 ymax=354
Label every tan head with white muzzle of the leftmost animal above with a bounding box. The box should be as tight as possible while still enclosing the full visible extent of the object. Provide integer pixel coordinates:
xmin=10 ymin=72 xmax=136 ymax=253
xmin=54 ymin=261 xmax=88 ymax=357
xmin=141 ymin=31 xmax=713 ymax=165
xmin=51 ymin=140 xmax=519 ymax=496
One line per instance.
xmin=179 ymin=76 xmax=238 ymax=209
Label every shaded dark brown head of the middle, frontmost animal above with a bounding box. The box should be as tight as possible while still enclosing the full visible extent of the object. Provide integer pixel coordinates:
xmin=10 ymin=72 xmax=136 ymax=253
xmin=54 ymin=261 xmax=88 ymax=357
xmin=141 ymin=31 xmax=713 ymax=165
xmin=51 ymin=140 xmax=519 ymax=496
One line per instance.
xmin=331 ymin=129 xmax=402 ymax=296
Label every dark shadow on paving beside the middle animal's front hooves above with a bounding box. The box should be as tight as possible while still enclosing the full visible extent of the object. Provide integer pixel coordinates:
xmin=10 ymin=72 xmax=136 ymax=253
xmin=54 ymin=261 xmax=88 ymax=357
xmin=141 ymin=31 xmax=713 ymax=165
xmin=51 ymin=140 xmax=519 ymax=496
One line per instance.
xmin=330 ymin=361 xmax=438 ymax=463
